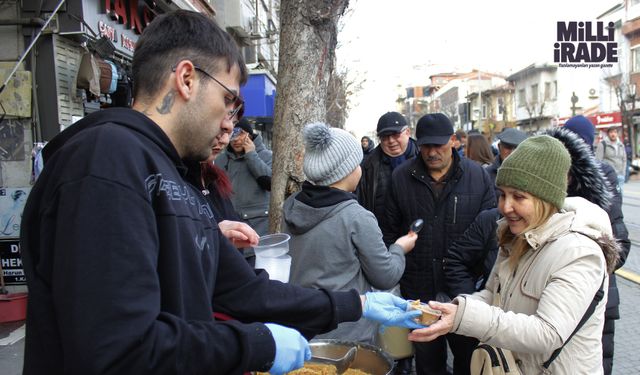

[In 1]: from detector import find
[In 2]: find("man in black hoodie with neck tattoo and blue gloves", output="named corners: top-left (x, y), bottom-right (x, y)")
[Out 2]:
top-left (21, 11), bottom-right (415, 375)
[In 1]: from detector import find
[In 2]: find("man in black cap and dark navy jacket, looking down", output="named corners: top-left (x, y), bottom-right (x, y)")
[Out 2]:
top-left (381, 113), bottom-right (496, 375)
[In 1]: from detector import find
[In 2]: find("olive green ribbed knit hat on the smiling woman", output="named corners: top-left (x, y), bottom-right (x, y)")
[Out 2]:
top-left (496, 135), bottom-right (571, 208)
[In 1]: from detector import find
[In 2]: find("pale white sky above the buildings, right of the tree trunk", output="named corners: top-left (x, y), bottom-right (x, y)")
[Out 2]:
top-left (336, 0), bottom-right (622, 137)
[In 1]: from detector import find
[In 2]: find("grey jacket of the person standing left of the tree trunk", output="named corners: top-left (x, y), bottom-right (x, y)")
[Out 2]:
top-left (216, 135), bottom-right (271, 236)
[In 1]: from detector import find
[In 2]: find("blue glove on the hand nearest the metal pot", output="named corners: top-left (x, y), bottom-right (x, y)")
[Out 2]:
top-left (265, 323), bottom-right (311, 375)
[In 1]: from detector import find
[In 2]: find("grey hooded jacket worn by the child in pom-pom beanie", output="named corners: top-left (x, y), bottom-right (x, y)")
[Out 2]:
top-left (283, 189), bottom-right (405, 343)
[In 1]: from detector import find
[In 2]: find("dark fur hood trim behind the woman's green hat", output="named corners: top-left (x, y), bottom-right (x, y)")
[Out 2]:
top-left (543, 127), bottom-right (612, 211)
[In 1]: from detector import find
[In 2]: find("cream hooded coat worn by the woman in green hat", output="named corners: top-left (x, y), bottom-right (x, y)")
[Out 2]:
top-left (453, 197), bottom-right (618, 375)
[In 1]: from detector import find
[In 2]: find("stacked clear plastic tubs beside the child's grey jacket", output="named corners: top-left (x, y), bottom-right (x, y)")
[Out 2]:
top-left (253, 233), bottom-right (291, 283)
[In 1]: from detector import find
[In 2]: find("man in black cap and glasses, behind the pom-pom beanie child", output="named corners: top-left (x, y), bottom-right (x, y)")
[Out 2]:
top-left (357, 112), bottom-right (418, 229)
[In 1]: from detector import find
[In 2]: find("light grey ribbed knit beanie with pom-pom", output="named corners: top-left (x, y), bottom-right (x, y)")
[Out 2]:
top-left (302, 123), bottom-right (362, 186)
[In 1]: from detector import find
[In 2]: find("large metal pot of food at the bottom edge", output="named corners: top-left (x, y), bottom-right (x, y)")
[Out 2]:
top-left (309, 339), bottom-right (393, 375)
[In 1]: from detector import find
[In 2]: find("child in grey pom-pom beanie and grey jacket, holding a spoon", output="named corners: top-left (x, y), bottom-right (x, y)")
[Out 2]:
top-left (283, 123), bottom-right (417, 343)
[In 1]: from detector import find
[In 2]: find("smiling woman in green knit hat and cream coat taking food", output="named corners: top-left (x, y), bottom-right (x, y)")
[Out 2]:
top-left (409, 135), bottom-right (618, 374)
